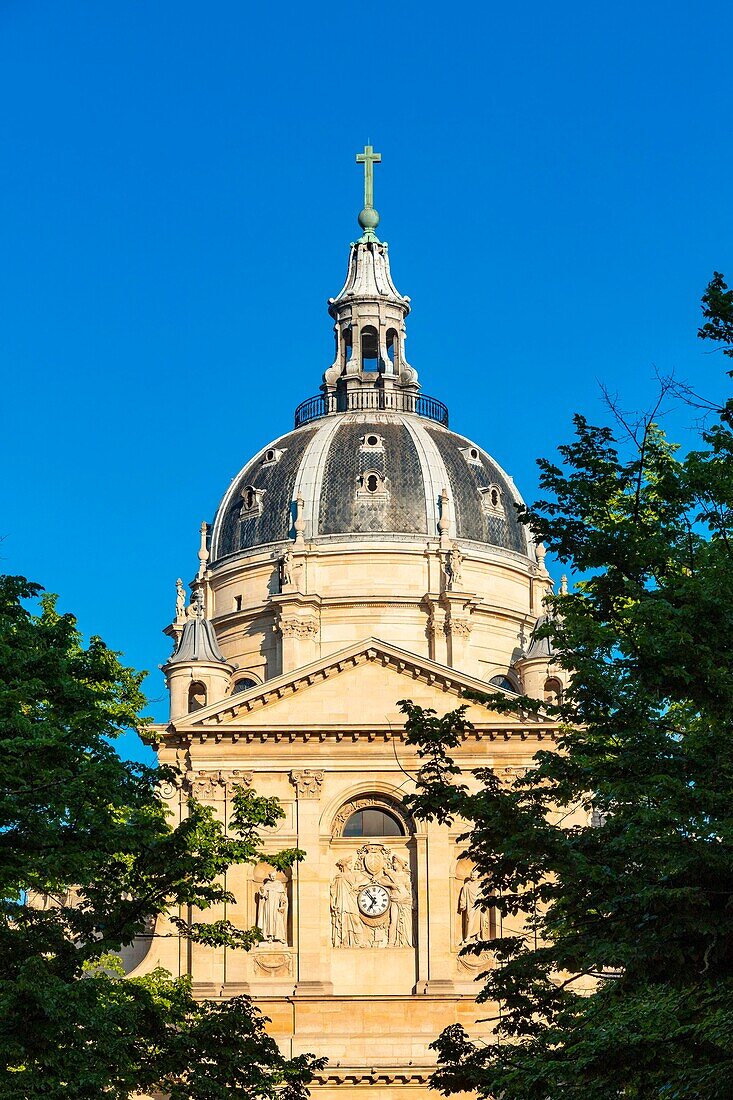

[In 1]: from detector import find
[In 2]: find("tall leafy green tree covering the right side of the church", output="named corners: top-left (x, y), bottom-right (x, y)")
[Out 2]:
top-left (403, 275), bottom-right (733, 1100)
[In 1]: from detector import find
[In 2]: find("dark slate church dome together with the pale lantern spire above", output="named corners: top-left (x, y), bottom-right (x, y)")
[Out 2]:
top-left (210, 167), bottom-right (528, 564)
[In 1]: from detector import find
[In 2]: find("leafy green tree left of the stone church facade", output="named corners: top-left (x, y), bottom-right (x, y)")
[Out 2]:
top-left (0, 576), bottom-right (319, 1100)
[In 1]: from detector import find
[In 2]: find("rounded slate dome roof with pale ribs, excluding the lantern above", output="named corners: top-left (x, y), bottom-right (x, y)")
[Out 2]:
top-left (210, 410), bottom-right (527, 564)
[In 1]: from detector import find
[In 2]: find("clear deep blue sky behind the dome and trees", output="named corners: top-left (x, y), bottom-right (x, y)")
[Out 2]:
top-left (0, 0), bottom-right (733, 761)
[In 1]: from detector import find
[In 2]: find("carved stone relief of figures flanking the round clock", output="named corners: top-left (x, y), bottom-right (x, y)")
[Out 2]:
top-left (330, 844), bottom-right (415, 947)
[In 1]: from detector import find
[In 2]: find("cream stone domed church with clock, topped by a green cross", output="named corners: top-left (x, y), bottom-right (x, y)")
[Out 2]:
top-left (138, 146), bottom-right (562, 1100)
